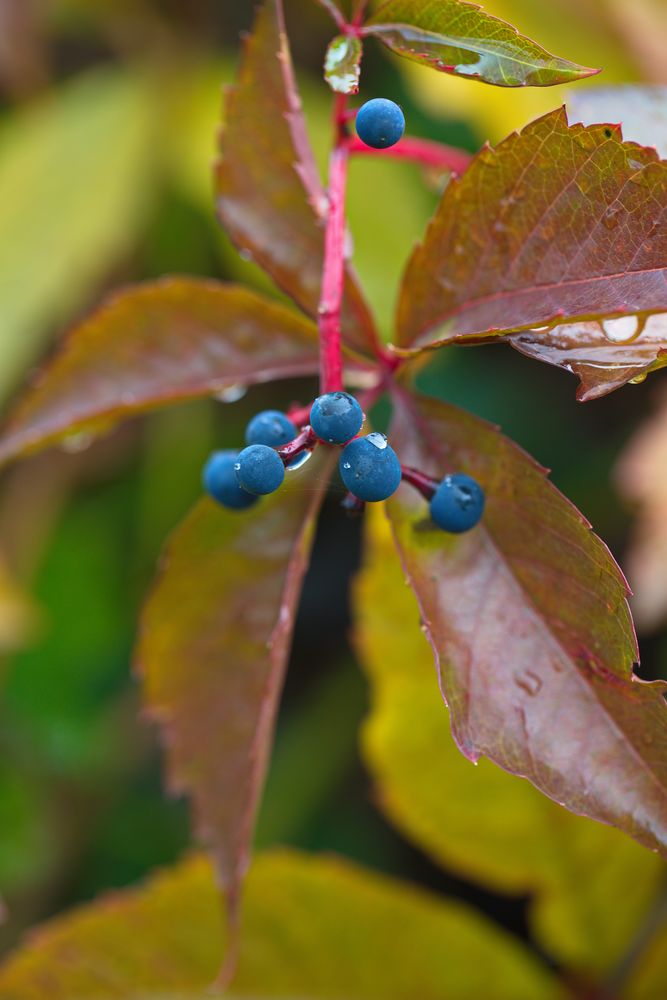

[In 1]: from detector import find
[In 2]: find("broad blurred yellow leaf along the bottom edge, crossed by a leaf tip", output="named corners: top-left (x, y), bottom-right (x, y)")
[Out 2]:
top-left (0, 851), bottom-right (566, 1000)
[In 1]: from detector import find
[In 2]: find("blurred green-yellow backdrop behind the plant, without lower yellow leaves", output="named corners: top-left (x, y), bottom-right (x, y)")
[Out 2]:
top-left (0, 0), bottom-right (667, 992)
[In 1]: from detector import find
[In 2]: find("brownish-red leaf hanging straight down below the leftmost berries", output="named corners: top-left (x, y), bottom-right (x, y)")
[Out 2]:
top-left (137, 453), bottom-right (333, 924)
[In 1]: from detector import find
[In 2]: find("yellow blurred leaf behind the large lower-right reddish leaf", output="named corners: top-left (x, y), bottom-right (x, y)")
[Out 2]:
top-left (354, 511), bottom-right (665, 976)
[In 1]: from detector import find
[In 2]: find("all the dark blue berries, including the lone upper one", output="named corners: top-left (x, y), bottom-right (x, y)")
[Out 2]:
top-left (203, 98), bottom-right (484, 534)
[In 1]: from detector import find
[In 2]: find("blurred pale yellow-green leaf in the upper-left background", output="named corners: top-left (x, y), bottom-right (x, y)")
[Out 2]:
top-left (0, 70), bottom-right (154, 400)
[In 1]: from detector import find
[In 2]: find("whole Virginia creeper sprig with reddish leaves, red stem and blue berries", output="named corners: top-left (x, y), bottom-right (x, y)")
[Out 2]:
top-left (0, 0), bottom-right (667, 988)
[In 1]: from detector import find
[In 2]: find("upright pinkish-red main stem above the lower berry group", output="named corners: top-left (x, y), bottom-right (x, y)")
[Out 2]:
top-left (318, 105), bottom-right (348, 393)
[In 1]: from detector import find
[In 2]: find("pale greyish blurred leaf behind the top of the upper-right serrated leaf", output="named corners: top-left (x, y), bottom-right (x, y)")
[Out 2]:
top-left (567, 84), bottom-right (667, 159)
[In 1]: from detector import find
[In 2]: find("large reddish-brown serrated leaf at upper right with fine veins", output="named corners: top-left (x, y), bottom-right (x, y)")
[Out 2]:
top-left (398, 109), bottom-right (667, 347)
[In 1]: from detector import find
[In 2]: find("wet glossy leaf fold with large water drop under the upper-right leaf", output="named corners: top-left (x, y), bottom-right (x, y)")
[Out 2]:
top-left (508, 313), bottom-right (667, 403)
